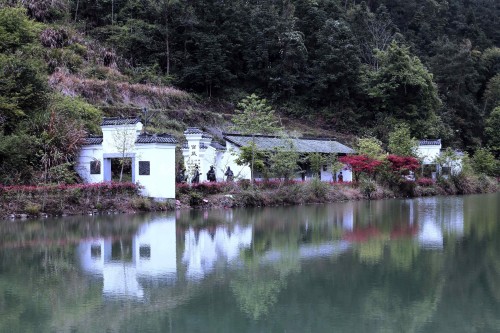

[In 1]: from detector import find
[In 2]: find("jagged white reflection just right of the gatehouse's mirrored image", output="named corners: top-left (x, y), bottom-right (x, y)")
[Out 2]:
top-left (182, 225), bottom-right (252, 278)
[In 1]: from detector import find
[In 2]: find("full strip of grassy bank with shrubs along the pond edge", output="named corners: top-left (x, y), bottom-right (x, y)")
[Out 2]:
top-left (0, 175), bottom-right (500, 219)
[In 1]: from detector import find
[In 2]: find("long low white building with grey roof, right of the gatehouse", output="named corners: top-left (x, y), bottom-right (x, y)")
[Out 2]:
top-left (182, 127), bottom-right (354, 181)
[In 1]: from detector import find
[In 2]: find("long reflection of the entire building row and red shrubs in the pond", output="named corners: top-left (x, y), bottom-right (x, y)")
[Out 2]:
top-left (77, 193), bottom-right (464, 299)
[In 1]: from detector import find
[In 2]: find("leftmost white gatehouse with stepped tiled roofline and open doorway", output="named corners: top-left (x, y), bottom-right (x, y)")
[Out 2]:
top-left (76, 118), bottom-right (177, 199)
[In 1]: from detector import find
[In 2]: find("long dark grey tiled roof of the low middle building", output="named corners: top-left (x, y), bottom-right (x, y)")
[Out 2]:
top-left (223, 133), bottom-right (355, 154)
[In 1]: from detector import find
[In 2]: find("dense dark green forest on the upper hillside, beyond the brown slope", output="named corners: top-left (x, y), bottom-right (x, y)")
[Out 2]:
top-left (42, 0), bottom-right (500, 149)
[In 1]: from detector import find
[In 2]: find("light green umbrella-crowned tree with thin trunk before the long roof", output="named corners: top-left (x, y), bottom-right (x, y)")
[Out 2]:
top-left (232, 94), bottom-right (280, 183)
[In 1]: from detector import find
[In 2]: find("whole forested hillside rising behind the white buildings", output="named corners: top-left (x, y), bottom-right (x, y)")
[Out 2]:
top-left (0, 0), bottom-right (500, 184)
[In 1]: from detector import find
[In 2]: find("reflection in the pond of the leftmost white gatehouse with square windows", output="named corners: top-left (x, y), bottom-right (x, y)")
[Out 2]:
top-left (78, 216), bottom-right (177, 298)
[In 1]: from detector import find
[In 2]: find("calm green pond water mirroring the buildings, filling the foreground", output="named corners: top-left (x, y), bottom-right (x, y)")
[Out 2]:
top-left (0, 193), bottom-right (500, 333)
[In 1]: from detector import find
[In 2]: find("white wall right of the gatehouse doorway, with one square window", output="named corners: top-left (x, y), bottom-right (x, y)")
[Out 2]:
top-left (135, 143), bottom-right (175, 199)
